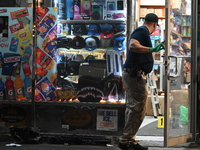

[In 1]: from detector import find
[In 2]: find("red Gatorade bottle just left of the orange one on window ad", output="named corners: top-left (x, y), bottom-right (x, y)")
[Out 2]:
top-left (5, 76), bottom-right (15, 100)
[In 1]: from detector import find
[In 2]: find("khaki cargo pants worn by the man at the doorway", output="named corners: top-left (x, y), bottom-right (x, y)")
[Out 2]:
top-left (120, 71), bottom-right (148, 144)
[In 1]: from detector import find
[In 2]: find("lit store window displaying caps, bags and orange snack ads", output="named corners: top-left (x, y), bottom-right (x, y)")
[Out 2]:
top-left (36, 0), bottom-right (126, 103)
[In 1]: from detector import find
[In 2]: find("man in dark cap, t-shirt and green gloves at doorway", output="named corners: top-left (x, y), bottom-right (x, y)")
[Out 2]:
top-left (118, 13), bottom-right (165, 150)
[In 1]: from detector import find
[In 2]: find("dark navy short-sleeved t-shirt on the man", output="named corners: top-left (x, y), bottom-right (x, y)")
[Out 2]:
top-left (124, 26), bottom-right (154, 73)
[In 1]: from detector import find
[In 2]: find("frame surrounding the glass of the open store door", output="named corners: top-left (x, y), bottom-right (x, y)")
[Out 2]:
top-left (164, 0), bottom-right (198, 147)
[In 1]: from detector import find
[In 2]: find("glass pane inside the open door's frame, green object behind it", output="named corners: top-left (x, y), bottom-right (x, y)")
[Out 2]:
top-left (169, 0), bottom-right (192, 137)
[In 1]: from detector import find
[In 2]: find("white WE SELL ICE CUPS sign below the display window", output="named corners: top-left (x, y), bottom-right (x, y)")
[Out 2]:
top-left (96, 109), bottom-right (118, 131)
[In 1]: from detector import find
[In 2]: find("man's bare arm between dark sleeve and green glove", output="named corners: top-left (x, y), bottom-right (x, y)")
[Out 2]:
top-left (129, 39), bottom-right (150, 53)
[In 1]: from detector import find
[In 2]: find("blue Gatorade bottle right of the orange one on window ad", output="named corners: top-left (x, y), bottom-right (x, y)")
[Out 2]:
top-left (24, 74), bottom-right (32, 100)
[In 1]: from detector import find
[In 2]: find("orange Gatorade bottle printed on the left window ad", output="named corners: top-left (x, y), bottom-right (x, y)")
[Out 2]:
top-left (14, 75), bottom-right (26, 101)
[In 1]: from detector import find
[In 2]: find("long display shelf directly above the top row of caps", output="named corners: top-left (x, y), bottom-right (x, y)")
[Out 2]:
top-left (60, 20), bottom-right (125, 24)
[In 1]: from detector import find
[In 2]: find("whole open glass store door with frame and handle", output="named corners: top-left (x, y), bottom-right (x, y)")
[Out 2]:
top-left (164, 0), bottom-right (196, 147)
